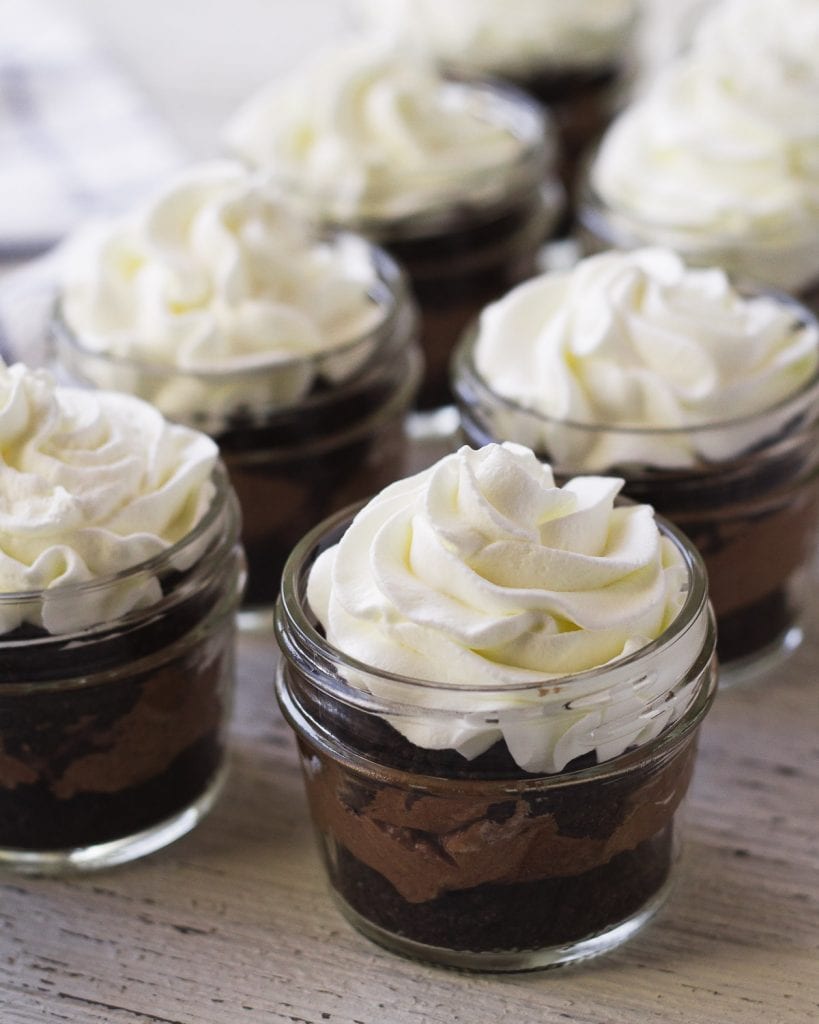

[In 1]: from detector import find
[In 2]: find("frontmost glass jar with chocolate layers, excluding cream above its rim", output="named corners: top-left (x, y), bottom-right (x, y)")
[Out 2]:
top-left (276, 501), bottom-right (716, 971)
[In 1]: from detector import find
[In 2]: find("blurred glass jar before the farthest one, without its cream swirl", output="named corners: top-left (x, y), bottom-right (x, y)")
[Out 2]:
top-left (266, 81), bottom-right (563, 409)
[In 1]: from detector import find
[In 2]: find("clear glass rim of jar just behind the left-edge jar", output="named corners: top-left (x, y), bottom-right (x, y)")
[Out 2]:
top-left (51, 234), bottom-right (413, 383)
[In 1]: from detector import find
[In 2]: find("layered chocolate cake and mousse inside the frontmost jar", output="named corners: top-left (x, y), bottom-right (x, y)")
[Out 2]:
top-left (285, 663), bottom-right (696, 952)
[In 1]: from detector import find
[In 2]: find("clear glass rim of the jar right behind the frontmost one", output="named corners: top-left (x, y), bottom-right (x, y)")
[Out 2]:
top-left (452, 288), bottom-right (819, 437)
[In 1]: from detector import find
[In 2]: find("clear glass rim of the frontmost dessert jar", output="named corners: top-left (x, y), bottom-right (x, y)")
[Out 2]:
top-left (275, 493), bottom-right (707, 696)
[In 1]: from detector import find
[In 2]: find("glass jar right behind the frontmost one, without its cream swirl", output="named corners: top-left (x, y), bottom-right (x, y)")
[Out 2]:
top-left (452, 323), bottom-right (819, 684)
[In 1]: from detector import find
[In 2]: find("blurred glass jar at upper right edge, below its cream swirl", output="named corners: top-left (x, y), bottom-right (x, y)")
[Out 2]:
top-left (577, 169), bottom-right (819, 313)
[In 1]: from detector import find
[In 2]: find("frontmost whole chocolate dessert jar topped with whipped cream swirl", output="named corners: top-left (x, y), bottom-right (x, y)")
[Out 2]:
top-left (276, 444), bottom-right (716, 971)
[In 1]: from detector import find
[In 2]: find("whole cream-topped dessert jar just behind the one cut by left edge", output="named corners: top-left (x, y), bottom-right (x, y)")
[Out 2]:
top-left (55, 162), bottom-right (421, 608)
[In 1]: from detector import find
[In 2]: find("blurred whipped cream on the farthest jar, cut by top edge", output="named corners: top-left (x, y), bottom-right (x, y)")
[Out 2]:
top-left (354, 0), bottom-right (637, 75)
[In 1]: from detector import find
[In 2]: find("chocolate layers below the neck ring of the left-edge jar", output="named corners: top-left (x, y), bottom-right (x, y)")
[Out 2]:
top-left (0, 624), bottom-right (232, 851)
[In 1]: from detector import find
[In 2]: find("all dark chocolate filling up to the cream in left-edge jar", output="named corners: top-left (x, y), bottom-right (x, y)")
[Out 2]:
top-left (0, 557), bottom-right (232, 852)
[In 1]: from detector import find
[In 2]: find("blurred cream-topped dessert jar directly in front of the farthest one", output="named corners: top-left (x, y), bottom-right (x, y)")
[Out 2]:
top-left (227, 39), bottom-right (562, 408)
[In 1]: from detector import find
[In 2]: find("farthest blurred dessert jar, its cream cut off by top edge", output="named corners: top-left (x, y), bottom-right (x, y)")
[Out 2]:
top-left (351, 0), bottom-right (638, 201)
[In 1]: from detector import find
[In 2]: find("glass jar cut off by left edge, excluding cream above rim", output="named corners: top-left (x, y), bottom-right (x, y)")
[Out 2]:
top-left (0, 464), bottom-right (244, 873)
